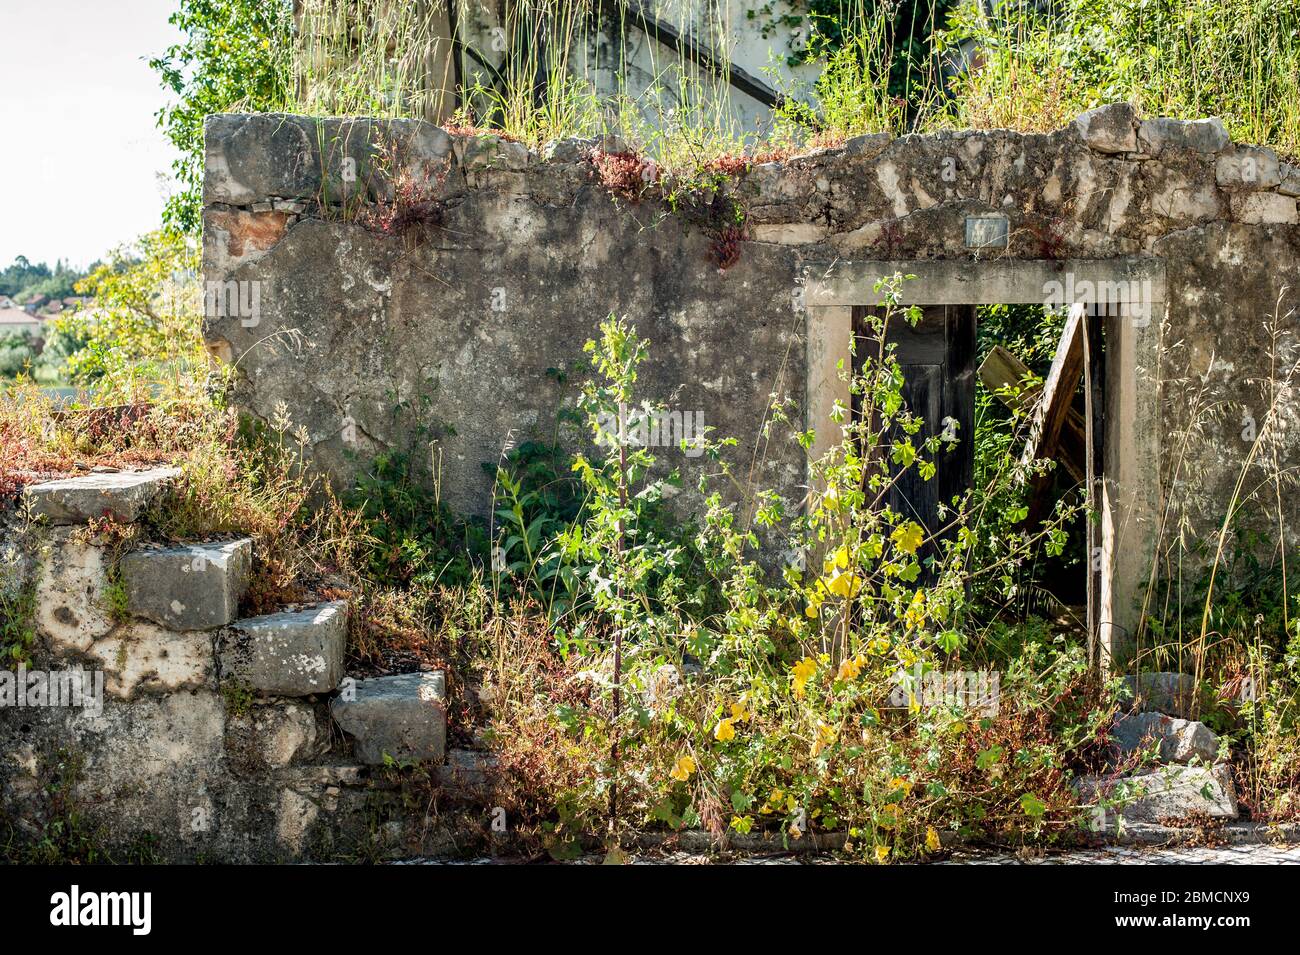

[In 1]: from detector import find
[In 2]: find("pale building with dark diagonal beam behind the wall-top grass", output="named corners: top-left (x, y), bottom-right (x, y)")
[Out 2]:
top-left (295, 0), bottom-right (818, 131)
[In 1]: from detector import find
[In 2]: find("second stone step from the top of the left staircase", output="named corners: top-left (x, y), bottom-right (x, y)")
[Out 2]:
top-left (118, 538), bottom-right (252, 630)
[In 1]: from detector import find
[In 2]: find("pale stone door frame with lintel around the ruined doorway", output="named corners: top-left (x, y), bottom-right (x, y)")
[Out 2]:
top-left (800, 257), bottom-right (1167, 669)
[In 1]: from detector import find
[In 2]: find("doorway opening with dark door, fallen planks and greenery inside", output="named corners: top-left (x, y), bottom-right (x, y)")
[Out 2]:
top-left (852, 303), bottom-right (1105, 621)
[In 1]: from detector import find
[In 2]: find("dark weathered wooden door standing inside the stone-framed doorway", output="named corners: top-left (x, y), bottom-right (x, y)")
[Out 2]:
top-left (853, 305), bottom-right (975, 556)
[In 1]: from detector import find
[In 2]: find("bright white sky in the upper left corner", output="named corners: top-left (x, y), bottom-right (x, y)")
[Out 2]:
top-left (0, 0), bottom-right (179, 268)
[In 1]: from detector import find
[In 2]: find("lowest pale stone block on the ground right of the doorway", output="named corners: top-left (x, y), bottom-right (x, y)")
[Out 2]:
top-left (1079, 763), bottom-right (1238, 828)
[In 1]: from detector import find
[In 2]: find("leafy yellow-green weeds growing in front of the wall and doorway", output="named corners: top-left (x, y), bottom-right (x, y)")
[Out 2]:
top-left (473, 279), bottom-right (1110, 860)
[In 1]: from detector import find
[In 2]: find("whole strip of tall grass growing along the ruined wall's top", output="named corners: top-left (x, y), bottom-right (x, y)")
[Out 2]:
top-left (283, 0), bottom-right (1300, 155)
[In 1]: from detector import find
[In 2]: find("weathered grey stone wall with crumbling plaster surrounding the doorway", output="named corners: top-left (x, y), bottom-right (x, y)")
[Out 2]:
top-left (204, 105), bottom-right (1300, 631)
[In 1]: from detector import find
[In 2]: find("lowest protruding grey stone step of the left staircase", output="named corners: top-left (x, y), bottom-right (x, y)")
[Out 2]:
top-left (330, 670), bottom-right (447, 765)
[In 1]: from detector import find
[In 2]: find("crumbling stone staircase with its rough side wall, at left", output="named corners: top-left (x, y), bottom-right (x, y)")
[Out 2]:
top-left (0, 468), bottom-right (457, 860)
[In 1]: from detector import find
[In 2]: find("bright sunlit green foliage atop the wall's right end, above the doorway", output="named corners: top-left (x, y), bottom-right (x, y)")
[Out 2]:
top-left (940, 0), bottom-right (1300, 153)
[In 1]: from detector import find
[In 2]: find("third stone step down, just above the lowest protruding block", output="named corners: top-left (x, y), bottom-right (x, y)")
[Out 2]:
top-left (217, 600), bottom-right (347, 696)
